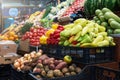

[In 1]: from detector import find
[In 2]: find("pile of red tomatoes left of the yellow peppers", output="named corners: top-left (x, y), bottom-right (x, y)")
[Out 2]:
top-left (22, 27), bottom-right (47, 46)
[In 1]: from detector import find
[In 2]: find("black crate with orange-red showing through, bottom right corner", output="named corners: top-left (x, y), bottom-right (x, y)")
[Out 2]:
top-left (91, 66), bottom-right (120, 80)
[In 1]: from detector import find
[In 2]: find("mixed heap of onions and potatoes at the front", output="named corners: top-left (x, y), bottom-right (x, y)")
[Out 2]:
top-left (14, 50), bottom-right (81, 78)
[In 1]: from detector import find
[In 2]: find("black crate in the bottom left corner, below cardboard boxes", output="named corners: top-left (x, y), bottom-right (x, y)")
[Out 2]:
top-left (0, 64), bottom-right (11, 80)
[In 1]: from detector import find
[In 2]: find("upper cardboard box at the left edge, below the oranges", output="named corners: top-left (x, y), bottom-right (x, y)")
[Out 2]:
top-left (0, 41), bottom-right (17, 56)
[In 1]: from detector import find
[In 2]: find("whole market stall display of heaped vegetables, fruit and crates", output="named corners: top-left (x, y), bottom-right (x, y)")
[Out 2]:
top-left (0, 0), bottom-right (120, 80)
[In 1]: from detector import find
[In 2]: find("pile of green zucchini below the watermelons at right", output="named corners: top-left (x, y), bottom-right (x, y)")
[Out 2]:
top-left (93, 8), bottom-right (120, 34)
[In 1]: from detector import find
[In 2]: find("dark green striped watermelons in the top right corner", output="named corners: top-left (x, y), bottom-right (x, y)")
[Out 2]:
top-left (84, 0), bottom-right (117, 17)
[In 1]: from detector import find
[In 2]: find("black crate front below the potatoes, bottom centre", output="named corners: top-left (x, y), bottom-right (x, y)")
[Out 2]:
top-left (29, 67), bottom-right (91, 80)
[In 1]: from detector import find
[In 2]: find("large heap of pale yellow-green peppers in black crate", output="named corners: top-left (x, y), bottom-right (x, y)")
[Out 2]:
top-left (59, 18), bottom-right (115, 47)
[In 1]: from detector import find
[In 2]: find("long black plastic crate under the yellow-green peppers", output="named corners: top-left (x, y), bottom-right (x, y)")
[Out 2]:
top-left (41, 45), bottom-right (115, 64)
